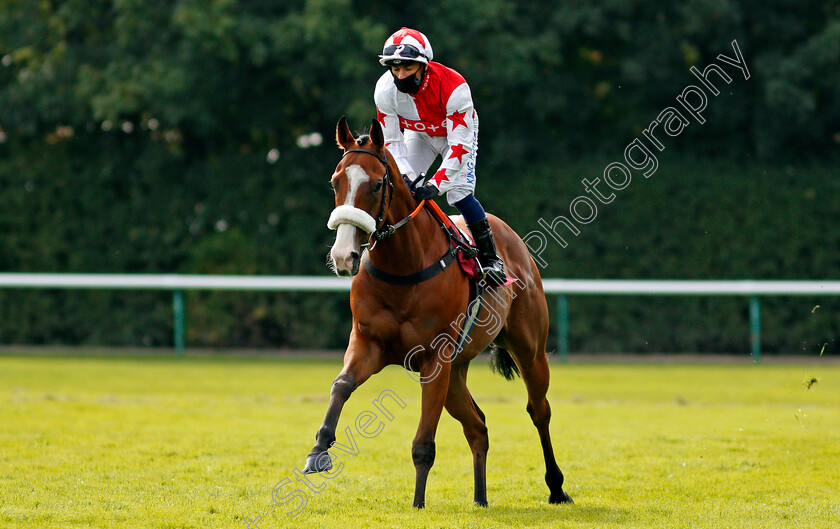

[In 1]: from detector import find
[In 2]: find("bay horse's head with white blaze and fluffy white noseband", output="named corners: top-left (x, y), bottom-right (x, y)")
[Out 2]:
top-left (327, 117), bottom-right (393, 276)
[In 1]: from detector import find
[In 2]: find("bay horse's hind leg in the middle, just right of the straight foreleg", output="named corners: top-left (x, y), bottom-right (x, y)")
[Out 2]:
top-left (445, 364), bottom-right (489, 507)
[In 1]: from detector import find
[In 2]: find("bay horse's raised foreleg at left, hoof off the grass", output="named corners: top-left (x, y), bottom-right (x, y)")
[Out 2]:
top-left (303, 332), bottom-right (384, 474)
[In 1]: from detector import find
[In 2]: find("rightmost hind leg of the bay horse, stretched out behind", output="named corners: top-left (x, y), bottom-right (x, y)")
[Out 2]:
top-left (501, 293), bottom-right (572, 503)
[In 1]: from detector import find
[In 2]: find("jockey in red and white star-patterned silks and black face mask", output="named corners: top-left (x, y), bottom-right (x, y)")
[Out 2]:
top-left (374, 28), bottom-right (506, 285)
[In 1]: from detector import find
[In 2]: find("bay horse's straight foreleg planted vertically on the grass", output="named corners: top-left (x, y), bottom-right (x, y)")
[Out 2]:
top-left (411, 357), bottom-right (451, 509)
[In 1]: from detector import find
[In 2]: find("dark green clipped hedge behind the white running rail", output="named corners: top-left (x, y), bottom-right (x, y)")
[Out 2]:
top-left (0, 142), bottom-right (840, 354)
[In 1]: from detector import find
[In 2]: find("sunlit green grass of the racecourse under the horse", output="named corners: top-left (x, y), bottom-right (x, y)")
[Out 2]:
top-left (0, 350), bottom-right (840, 529)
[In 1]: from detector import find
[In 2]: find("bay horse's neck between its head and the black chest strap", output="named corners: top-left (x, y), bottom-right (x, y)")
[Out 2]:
top-left (368, 190), bottom-right (448, 275)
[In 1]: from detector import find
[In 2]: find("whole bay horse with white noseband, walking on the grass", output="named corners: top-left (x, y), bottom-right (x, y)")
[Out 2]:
top-left (304, 117), bottom-right (572, 508)
